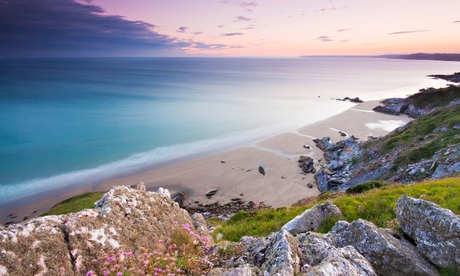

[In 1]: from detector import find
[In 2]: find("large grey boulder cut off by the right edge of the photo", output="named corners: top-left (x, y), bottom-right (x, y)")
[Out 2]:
top-left (395, 196), bottom-right (460, 270)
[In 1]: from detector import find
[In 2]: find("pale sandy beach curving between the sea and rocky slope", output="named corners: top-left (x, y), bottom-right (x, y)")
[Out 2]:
top-left (0, 101), bottom-right (411, 224)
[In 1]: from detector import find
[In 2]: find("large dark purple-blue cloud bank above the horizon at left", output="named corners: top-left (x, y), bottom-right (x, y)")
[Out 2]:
top-left (0, 0), bottom-right (184, 57)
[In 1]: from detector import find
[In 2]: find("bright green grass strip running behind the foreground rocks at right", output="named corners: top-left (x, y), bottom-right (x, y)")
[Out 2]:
top-left (217, 177), bottom-right (460, 241)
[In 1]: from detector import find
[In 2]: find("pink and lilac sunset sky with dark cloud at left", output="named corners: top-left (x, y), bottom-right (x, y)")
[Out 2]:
top-left (0, 0), bottom-right (460, 57)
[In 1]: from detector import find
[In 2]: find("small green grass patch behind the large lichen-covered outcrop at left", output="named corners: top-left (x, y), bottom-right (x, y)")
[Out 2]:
top-left (41, 192), bottom-right (106, 216)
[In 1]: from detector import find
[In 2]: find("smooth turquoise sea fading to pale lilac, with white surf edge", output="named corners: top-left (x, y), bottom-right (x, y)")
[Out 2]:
top-left (0, 57), bottom-right (460, 208)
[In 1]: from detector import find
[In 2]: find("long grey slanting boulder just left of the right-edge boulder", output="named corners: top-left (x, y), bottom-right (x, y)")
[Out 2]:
top-left (327, 219), bottom-right (439, 275)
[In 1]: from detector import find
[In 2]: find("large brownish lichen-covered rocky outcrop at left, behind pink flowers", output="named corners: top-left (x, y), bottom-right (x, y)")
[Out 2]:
top-left (0, 187), bottom-right (205, 275)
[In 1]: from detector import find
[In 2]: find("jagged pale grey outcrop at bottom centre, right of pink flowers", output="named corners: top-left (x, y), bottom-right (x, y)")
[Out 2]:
top-left (232, 230), bottom-right (377, 276)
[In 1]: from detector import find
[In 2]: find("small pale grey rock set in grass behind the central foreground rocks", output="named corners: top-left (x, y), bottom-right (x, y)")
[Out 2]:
top-left (281, 201), bottom-right (342, 235)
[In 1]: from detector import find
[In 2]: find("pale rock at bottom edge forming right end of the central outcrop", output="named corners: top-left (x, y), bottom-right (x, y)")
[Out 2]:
top-left (297, 232), bottom-right (377, 276)
